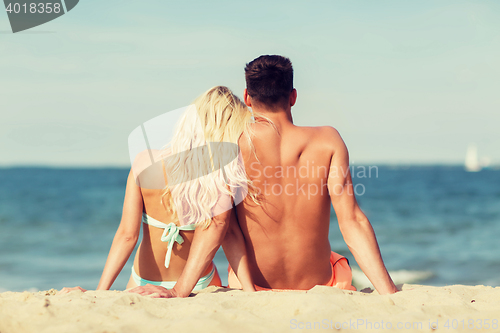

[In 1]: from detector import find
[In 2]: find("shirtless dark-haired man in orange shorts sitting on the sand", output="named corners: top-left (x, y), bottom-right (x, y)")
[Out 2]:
top-left (129, 55), bottom-right (397, 297)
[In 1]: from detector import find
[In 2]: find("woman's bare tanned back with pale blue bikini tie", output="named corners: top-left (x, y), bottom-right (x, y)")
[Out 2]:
top-left (127, 150), bottom-right (220, 288)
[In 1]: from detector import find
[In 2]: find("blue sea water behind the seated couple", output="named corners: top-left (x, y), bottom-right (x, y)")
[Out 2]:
top-left (0, 166), bottom-right (500, 291)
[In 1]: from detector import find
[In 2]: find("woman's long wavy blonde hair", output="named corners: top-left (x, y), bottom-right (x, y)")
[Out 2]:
top-left (162, 86), bottom-right (256, 226)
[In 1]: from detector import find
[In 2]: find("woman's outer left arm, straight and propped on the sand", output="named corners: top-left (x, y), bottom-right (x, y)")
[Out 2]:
top-left (97, 171), bottom-right (143, 290)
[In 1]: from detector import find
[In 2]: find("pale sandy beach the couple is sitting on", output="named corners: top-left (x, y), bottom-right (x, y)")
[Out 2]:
top-left (0, 284), bottom-right (500, 333)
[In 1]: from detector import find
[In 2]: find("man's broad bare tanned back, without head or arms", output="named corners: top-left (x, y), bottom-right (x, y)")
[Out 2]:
top-left (237, 120), bottom-right (338, 289)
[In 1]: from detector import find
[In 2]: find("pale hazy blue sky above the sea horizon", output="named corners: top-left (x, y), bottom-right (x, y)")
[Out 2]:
top-left (0, 0), bottom-right (500, 167)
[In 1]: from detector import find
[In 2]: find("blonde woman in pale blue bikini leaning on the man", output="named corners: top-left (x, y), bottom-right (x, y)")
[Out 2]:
top-left (61, 86), bottom-right (255, 296)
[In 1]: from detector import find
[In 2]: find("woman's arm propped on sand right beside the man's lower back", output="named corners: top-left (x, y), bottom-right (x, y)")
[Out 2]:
top-left (222, 209), bottom-right (255, 291)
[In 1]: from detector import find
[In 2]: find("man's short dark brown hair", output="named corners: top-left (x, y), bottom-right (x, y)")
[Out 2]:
top-left (245, 55), bottom-right (293, 104)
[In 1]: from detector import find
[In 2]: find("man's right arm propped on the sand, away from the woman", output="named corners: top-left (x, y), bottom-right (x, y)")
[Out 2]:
top-left (328, 129), bottom-right (398, 294)
